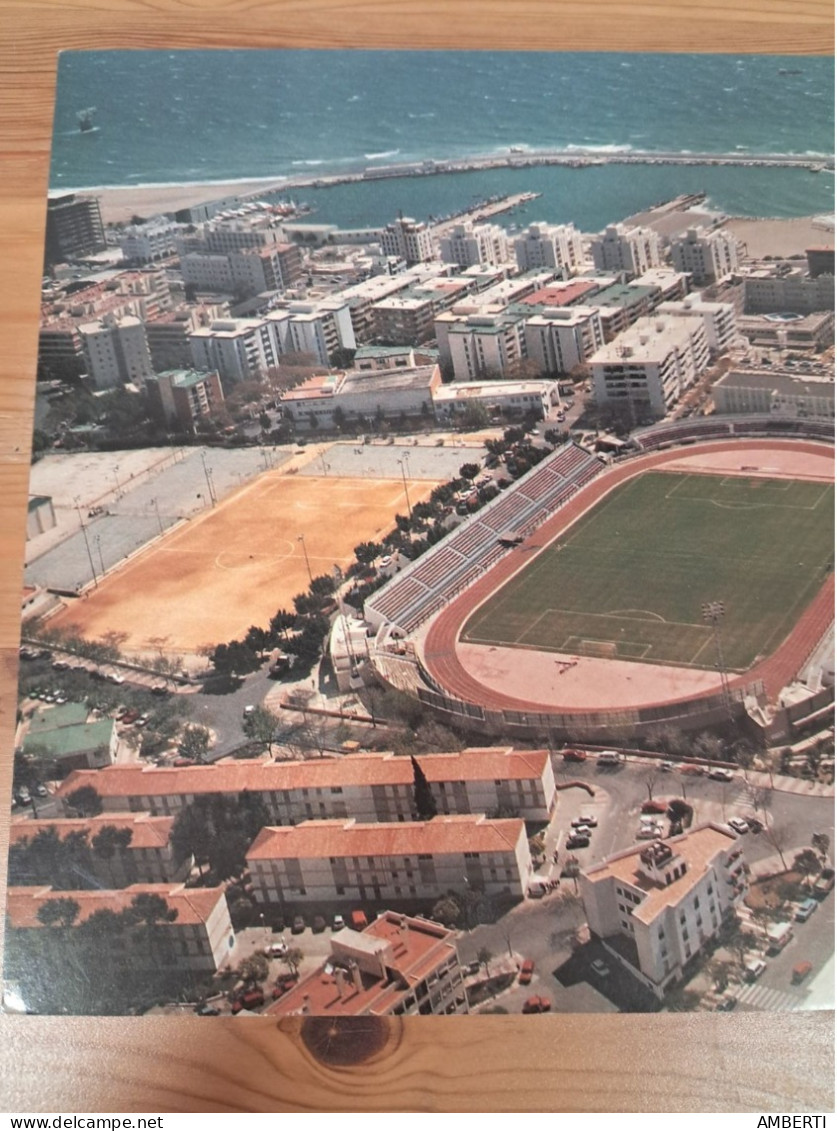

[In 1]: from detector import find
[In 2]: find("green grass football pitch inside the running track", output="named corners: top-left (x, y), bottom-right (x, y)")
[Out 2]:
top-left (463, 472), bottom-right (834, 671)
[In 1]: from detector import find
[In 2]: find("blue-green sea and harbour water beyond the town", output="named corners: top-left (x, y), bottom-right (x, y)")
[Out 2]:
top-left (50, 50), bottom-right (835, 231)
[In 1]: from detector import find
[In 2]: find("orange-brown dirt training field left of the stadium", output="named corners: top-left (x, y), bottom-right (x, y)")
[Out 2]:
top-left (51, 472), bottom-right (435, 654)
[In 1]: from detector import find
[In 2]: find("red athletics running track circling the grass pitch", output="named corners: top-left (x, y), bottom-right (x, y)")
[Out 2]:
top-left (419, 439), bottom-right (834, 715)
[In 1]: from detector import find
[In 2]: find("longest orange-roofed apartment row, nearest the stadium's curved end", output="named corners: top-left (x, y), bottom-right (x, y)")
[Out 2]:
top-left (57, 746), bottom-right (555, 824)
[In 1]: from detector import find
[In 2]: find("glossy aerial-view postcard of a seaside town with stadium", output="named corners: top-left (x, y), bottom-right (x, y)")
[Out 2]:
top-left (5, 50), bottom-right (835, 1017)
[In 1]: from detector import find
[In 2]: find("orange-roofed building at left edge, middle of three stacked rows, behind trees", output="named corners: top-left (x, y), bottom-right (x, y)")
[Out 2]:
top-left (9, 813), bottom-right (192, 888)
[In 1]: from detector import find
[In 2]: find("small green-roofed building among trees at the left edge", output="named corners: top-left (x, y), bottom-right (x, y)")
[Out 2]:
top-left (23, 702), bottom-right (119, 775)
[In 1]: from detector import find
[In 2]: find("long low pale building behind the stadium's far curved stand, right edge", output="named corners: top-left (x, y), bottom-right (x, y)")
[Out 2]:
top-left (713, 370), bottom-right (835, 421)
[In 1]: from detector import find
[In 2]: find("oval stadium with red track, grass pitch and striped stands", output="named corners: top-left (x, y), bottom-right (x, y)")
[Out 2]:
top-left (364, 416), bottom-right (834, 741)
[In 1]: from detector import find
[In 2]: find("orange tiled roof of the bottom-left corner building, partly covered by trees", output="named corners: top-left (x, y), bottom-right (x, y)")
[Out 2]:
top-left (7, 883), bottom-right (224, 927)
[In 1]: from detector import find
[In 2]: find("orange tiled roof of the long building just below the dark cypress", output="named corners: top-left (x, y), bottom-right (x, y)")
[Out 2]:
top-left (247, 814), bottom-right (524, 860)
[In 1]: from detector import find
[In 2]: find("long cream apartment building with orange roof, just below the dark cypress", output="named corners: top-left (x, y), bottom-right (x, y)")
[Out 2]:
top-left (247, 814), bottom-right (532, 906)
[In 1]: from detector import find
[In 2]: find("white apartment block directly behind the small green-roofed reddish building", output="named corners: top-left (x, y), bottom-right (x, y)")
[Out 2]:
top-left (189, 318), bottom-right (284, 388)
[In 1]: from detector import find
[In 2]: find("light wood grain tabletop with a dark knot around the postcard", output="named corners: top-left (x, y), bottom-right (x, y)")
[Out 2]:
top-left (0, 0), bottom-right (834, 1112)
